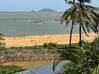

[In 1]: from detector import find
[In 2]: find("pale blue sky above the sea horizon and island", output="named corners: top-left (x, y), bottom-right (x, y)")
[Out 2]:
top-left (0, 0), bottom-right (99, 11)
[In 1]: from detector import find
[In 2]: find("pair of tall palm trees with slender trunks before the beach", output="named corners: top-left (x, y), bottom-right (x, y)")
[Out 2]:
top-left (61, 0), bottom-right (99, 47)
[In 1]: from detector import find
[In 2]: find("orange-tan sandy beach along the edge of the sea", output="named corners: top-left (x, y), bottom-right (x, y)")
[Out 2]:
top-left (4, 33), bottom-right (97, 47)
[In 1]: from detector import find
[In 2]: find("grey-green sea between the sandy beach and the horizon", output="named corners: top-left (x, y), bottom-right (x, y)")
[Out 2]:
top-left (0, 12), bottom-right (78, 37)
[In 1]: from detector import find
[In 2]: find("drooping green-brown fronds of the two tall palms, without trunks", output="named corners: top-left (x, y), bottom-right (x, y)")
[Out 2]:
top-left (61, 3), bottom-right (99, 44)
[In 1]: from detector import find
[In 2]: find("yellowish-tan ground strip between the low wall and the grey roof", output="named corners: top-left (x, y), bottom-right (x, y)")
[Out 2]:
top-left (2, 60), bottom-right (53, 69)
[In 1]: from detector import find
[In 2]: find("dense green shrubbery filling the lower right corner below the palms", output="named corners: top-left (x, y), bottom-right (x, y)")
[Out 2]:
top-left (53, 42), bottom-right (99, 74)
